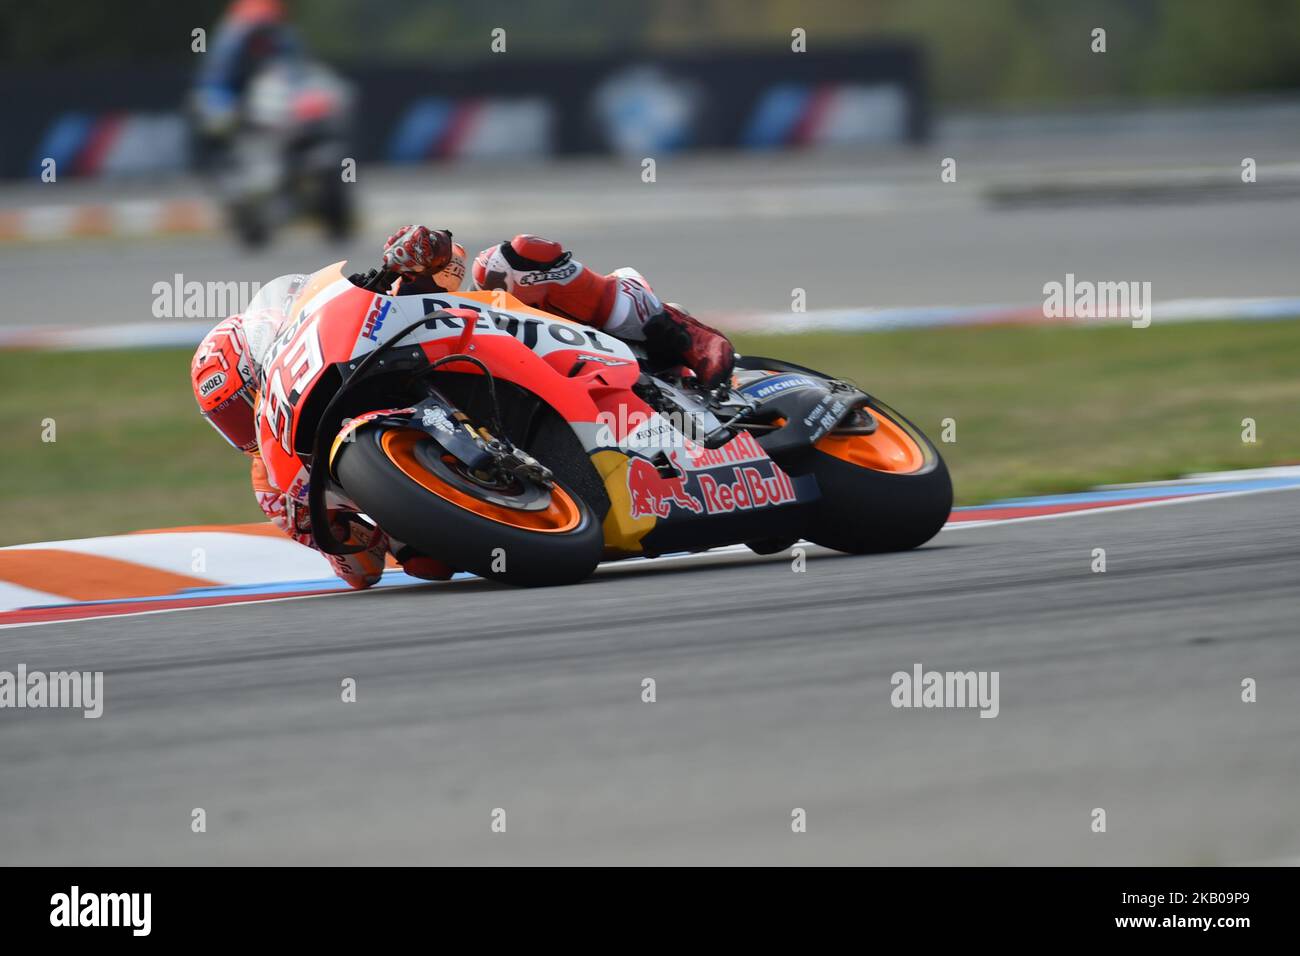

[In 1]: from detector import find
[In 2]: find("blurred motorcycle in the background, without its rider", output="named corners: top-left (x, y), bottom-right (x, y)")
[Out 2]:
top-left (220, 61), bottom-right (352, 248)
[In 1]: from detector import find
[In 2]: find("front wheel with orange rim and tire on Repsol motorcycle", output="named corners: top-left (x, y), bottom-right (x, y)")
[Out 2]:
top-left (335, 427), bottom-right (603, 587)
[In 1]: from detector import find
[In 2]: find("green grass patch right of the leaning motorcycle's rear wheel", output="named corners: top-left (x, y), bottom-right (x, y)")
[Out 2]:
top-left (737, 321), bottom-right (1300, 505)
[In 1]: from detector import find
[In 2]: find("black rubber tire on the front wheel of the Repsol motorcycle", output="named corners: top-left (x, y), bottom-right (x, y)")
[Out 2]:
top-left (335, 427), bottom-right (605, 587)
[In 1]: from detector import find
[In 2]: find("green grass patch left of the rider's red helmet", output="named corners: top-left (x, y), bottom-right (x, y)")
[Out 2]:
top-left (0, 349), bottom-right (261, 544)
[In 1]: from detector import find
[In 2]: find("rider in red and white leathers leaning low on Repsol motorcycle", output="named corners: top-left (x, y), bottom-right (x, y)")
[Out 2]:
top-left (190, 225), bottom-right (736, 588)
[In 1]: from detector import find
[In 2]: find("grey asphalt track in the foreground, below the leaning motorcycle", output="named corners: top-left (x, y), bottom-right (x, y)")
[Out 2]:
top-left (0, 490), bottom-right (1300, 864)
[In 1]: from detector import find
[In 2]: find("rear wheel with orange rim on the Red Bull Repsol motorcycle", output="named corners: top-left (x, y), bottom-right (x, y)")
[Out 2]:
top-left (781, 398), bottom-right (953, 554)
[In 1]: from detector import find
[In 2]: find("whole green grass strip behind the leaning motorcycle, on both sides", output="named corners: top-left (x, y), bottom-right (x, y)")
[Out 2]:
top-left (0, 323), bottom-right (1300, 544)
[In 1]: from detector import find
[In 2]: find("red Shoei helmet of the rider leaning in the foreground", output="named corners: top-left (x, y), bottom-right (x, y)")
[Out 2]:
top-left (190, 315), bottom-right (257, 453)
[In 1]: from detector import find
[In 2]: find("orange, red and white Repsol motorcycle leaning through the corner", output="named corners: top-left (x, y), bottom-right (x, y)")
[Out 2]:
top-left (250, 263), bottom-right (953, 585)
